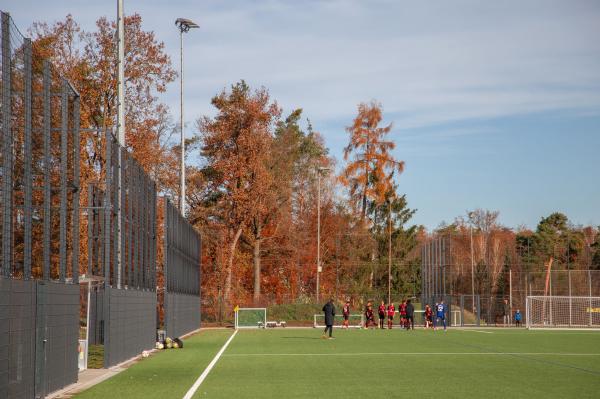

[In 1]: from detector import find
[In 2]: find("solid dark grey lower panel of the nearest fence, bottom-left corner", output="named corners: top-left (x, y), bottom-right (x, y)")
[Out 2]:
top-left (0, 278), bottom-right (79, 398)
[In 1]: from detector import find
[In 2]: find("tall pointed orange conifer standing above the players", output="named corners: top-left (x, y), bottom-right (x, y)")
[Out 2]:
top-left (341, 101), bottom-right (404, 220)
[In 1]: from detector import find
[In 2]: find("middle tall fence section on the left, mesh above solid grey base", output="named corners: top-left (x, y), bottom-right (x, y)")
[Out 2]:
top-left (87, 130), bottom-right (156, 367)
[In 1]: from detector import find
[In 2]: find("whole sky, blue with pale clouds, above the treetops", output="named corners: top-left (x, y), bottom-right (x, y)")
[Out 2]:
top-left (5, 0), bottom-right (600, 228)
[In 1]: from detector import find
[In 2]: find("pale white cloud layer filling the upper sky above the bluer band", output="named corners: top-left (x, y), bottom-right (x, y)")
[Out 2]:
top-left (7, 0), bottom-right (600, 131)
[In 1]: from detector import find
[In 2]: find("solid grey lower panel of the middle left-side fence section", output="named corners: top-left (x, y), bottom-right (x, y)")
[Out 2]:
top-left (104, 288), bottom-right (156, 367)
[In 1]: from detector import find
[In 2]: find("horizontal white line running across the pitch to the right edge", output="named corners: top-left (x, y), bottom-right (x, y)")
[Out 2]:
top-left (223, 352), bottom-right (600, 357)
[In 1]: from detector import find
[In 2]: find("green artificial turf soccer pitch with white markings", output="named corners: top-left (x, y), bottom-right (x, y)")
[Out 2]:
top-left (77, 328), bottom-right (600, 399)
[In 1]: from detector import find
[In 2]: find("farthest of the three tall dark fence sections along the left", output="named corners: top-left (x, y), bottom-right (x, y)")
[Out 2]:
top-left (164, 198), bottom-right (201, 337)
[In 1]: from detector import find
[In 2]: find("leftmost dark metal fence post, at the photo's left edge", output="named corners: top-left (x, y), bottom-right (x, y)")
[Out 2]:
top-left (2, 13), bottom-right (13, 276)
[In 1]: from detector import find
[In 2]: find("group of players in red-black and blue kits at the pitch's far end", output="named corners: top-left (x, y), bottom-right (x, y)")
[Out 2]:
top-left (342, 299), bottom-right (447, 331)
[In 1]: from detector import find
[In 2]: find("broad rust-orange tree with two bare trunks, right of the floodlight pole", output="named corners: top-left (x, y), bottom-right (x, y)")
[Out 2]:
top-left (198, 81), bottom-right (280, 299)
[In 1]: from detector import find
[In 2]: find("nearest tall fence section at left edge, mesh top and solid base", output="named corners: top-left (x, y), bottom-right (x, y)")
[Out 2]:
top-left (0, 12), bottom-right (80, 398)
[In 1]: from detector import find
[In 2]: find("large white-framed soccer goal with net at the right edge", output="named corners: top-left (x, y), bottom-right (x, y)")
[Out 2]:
top-left (525, 296), bottom-right (600, 328)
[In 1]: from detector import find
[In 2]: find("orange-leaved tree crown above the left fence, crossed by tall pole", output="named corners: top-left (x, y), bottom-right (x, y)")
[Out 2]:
top-left (30, 14), bottom-right (177, 190)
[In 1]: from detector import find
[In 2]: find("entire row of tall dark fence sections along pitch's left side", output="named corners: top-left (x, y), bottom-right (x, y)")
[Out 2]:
top-left (0, 12), bottom-right (200, 398)
